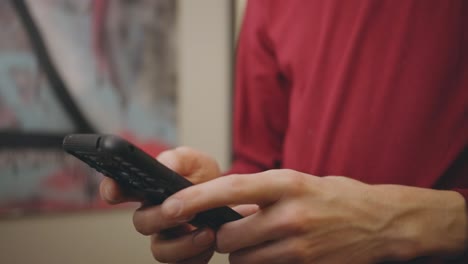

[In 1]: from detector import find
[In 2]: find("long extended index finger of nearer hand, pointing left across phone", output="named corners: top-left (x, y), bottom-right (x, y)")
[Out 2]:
top-left (162, 170), bottom-right (302, 219)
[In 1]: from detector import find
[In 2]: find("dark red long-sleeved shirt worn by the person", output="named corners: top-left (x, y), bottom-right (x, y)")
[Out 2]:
top-left (232, 0), bottom-right (468, 263)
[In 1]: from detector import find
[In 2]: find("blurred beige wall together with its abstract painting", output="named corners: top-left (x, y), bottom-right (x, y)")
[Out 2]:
top-left (0, 0), bottom-right (245, 264)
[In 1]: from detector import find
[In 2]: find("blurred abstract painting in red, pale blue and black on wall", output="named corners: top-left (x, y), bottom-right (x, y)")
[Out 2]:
top-left (0, 0), bottom-right (177, 216)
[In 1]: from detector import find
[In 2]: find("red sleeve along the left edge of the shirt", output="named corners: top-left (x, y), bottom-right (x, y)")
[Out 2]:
top-left (229, 0), bottom-right (289, 173)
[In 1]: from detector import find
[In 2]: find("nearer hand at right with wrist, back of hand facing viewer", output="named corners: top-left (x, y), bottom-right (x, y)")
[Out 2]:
top-left (158, 170), bottom-right (467, 264)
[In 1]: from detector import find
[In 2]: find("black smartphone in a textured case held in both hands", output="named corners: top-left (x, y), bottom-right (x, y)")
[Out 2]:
top-left (63, 134), bottom-right (242, 229)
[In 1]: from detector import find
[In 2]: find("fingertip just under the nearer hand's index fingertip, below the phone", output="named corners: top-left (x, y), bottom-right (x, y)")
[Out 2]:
top-left (133, 206), bottom-right (192, 236)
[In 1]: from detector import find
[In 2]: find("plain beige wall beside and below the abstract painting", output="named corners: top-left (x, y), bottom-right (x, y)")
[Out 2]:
top-left (0, 0), bottom-right (231, 264)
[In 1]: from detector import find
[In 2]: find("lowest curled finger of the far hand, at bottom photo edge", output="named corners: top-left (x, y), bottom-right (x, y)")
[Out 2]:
top-left (151, 228), bottom-right (215, 263)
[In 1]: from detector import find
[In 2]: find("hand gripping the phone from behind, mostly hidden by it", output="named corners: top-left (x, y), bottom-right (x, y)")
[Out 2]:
top-left (100, 147), bottom-right (221, 263)
